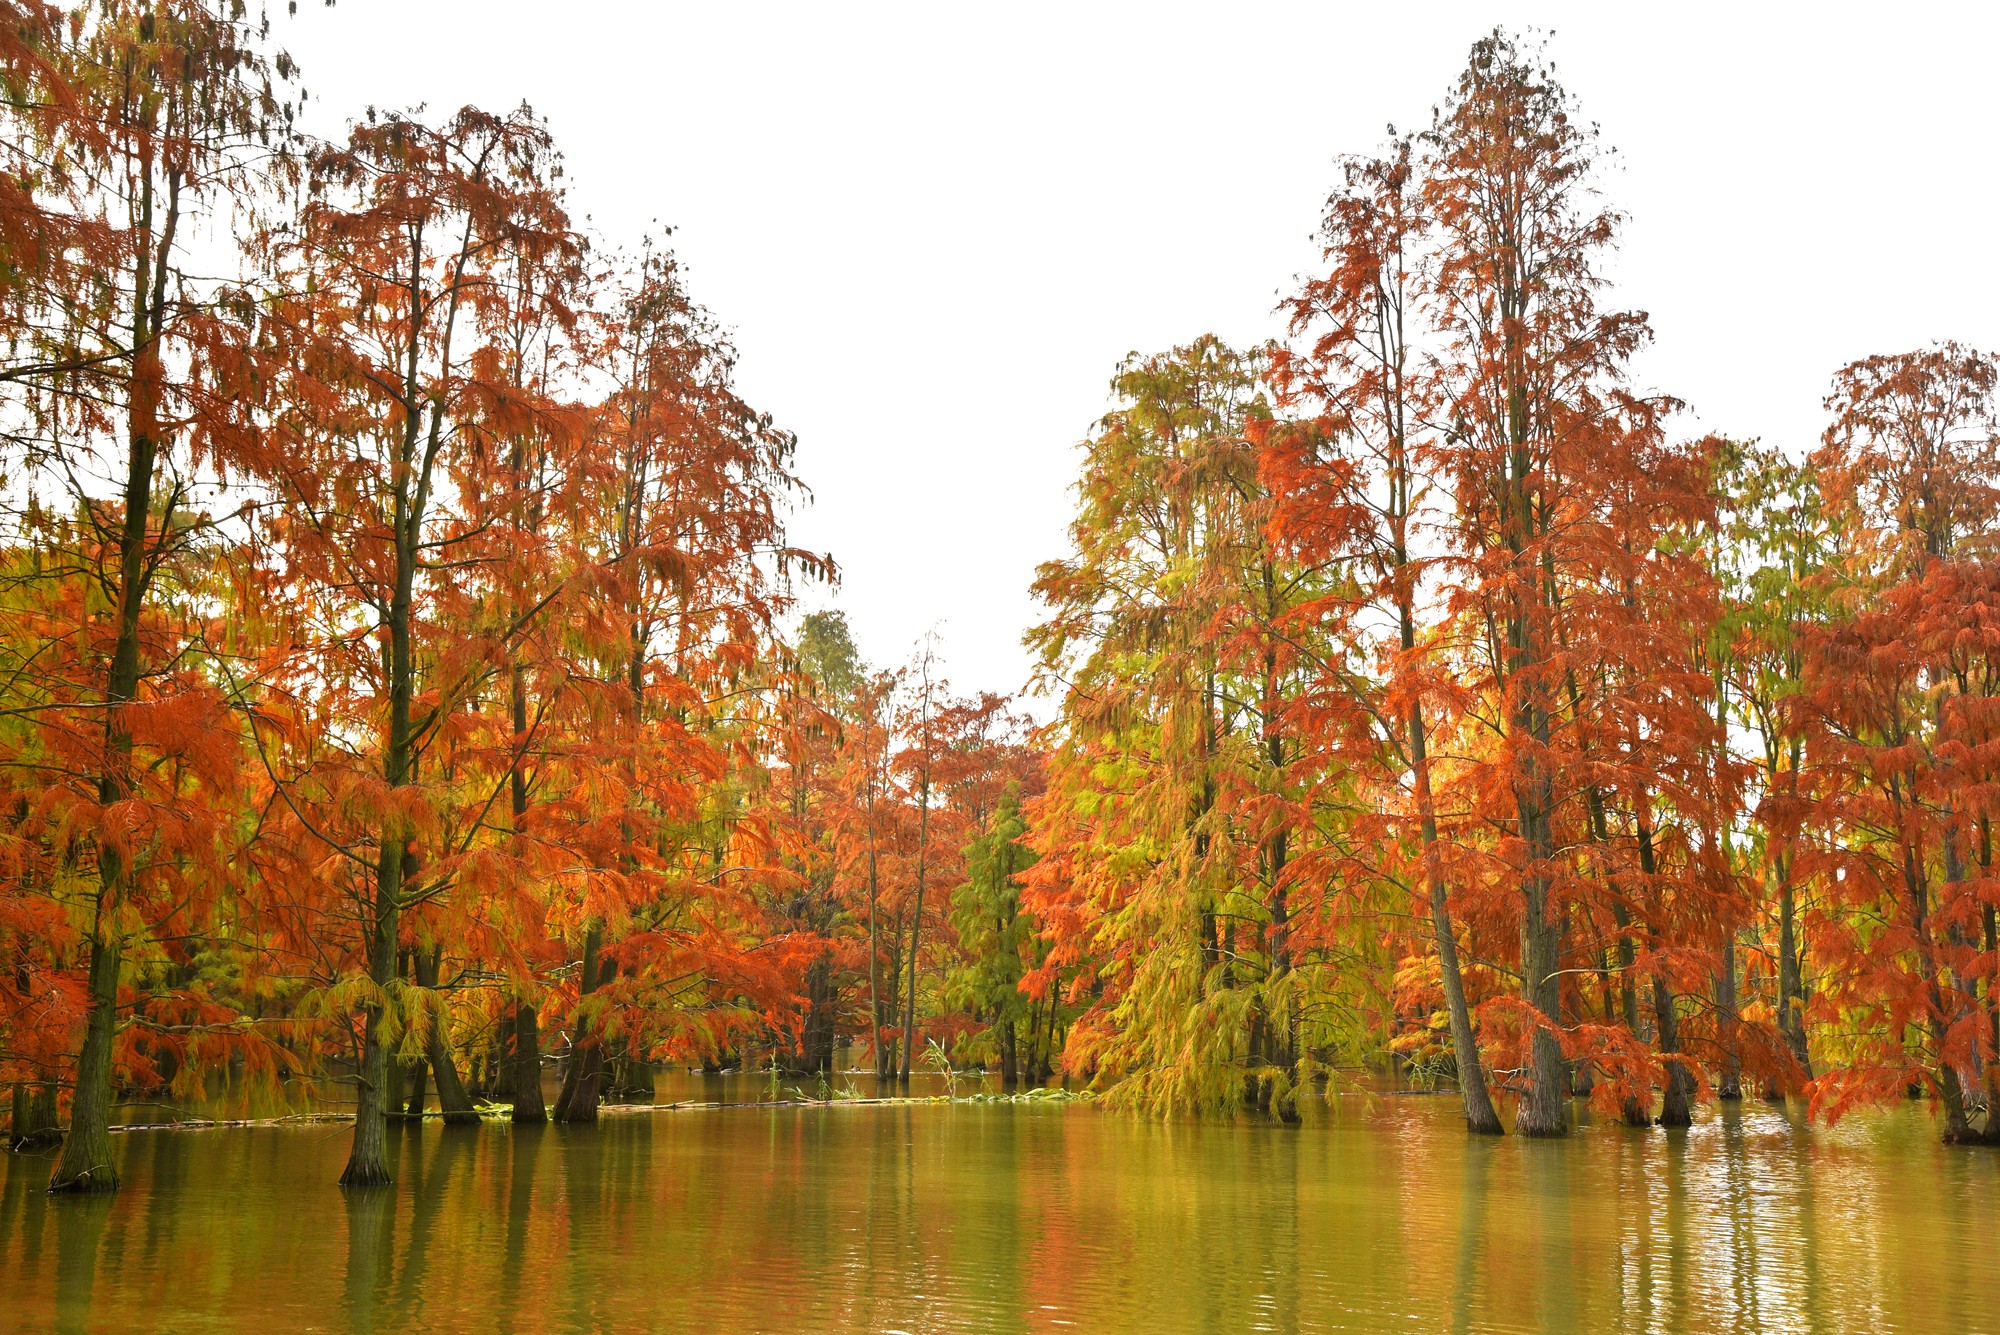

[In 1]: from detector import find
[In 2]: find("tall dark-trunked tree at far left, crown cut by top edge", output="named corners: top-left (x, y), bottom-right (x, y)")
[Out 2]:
top-left (0, 0), bottom-right (292, 1191)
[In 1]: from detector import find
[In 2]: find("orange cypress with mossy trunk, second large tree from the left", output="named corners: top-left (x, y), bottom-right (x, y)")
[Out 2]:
top-left (254, 108), bottom-right (582, 1187)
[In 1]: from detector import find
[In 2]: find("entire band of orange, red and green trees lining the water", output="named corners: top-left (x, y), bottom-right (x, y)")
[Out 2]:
top-left (0, 0), bottom-right (2000, 1191)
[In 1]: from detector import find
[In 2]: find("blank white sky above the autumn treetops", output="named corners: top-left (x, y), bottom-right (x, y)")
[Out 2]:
top-left (276, 0), bottom-right (2000, 691)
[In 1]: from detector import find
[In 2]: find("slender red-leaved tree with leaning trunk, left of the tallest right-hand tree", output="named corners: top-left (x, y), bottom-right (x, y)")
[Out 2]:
top-left (1264, 138), bottom-right (1502, 1135)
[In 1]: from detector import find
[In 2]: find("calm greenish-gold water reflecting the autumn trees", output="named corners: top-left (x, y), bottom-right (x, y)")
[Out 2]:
top-left (0, 1097), bottom-right (2000, 1335)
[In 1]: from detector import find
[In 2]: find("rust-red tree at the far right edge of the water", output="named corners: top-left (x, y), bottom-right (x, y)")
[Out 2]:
top-left (1796, 344), bottom-right (2000, 1141)
